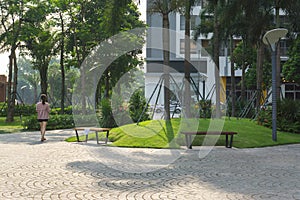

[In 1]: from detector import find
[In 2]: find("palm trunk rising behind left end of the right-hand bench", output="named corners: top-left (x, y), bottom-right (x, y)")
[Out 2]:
top-left (183, 1), bottom-right (191, 118)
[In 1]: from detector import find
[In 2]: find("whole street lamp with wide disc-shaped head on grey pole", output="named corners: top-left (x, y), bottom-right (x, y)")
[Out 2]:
top-left (263, 28), bottom-right (288, 141)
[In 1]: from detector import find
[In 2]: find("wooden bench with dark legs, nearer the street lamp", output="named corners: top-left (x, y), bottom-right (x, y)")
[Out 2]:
top-left (181, 131), bottom-right (237, 149)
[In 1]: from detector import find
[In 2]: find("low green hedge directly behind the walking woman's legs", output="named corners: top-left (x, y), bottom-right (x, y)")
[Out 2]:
top-left (22, 115), bottom-right (74, 130)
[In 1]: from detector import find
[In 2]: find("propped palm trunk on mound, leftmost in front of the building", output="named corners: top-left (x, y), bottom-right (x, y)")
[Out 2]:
top-left (163, 13), bottom-right (171, 121)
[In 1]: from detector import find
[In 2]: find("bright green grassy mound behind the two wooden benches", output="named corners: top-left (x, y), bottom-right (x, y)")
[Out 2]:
top-left (67, 119), bottom-right (300, 148)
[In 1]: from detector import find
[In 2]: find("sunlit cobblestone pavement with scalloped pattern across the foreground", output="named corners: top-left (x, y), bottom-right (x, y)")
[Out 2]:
top-left (0, 130), bottom-right (300, 200)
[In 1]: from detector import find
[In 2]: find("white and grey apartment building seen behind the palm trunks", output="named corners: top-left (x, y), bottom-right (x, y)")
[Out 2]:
top-left (145, 1), bottom-right (300, 109)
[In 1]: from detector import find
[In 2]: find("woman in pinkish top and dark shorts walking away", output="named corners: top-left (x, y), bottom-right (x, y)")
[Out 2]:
top-left (36, 94), bottom-right (50, 142)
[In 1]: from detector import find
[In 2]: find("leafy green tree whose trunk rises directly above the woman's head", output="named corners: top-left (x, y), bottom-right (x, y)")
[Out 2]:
top-left (22, 1), bottom-right (56, 94)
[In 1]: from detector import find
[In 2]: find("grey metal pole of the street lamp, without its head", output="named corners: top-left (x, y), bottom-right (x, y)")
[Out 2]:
top-left (272, 45), bottom-right (277, 141)
